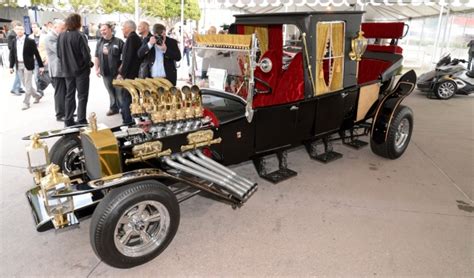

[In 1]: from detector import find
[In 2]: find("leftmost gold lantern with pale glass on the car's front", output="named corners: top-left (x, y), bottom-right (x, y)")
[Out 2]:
top-left (26, 134), bottom-right (49, 184)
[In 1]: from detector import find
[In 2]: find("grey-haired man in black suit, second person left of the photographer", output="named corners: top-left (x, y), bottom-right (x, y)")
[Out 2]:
top-left (117, 20), bottom-right (142, 124)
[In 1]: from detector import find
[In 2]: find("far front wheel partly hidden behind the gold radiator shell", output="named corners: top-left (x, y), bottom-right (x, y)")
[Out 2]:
top-left (50, 135), bottom-right (84, 174)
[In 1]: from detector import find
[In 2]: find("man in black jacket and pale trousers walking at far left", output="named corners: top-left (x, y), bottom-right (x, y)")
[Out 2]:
top-left (10, 25), bottom-right (44, 110)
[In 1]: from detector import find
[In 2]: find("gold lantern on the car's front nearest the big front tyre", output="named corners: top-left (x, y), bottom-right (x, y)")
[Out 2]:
top-left (41, 164), bottom-right (77, 229)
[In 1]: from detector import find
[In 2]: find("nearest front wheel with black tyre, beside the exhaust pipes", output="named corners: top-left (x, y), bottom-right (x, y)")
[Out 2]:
top-left (90, 180), bottom-right (179, 268)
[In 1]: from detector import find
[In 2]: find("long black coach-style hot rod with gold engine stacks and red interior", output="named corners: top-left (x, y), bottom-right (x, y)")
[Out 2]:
top-left (25, 12), bottom-right (416, 268)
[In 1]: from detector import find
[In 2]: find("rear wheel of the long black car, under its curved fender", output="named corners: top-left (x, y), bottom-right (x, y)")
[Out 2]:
top-left (370, 105), bottom-right (413, 159)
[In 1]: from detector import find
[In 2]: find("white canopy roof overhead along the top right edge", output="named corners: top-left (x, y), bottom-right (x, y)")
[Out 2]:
top-left (216, 0), bottom-right (474, 21)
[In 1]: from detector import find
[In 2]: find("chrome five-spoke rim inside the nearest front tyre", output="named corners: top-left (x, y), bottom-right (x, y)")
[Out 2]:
top-left (114, 201), bottom-right (170, 257)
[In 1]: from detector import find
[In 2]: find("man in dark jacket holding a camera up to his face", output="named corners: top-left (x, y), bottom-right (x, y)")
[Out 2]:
top-left (138, 24), bottom-right (181, 85)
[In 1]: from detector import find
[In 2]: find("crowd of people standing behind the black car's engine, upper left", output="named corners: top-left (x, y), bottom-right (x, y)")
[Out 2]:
top-left (7, 14), bottom-right (184, 127)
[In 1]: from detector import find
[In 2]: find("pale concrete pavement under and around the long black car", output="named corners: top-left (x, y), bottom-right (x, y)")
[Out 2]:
top-left (0, 68), bottom-right (474, 277)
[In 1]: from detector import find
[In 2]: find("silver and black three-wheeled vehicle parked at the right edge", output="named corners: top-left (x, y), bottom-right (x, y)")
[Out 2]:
top-left (416, 53), bottom-right (474, 99)
